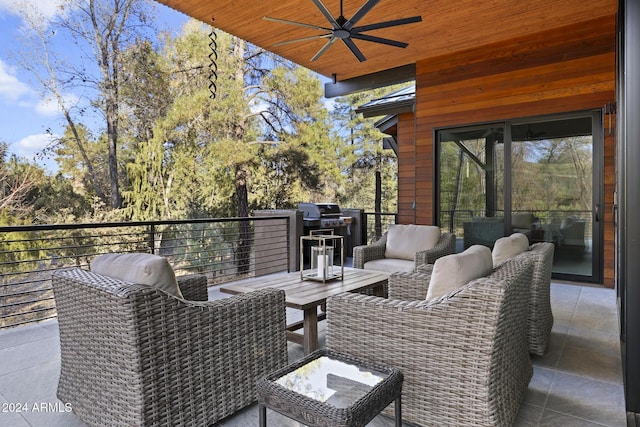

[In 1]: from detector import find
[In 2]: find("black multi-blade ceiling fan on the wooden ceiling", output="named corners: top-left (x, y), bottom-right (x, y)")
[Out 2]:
top-left (264, 0), bottom-right (422, 62)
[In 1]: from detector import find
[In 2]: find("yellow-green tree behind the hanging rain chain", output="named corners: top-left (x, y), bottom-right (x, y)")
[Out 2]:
top-left (125, 21), bottom-right (258, 219)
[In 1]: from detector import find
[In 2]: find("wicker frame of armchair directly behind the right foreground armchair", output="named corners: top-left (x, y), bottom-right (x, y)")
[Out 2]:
top-left (387, 242), bottom-right (554, 356)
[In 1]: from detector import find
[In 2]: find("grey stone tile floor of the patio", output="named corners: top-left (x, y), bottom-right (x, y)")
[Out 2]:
top-left (0, 283), bottom-right (627, 427)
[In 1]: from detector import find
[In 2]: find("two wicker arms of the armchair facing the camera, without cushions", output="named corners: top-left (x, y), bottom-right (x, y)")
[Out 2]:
top-left (353, 229), bottom-right (456, 270)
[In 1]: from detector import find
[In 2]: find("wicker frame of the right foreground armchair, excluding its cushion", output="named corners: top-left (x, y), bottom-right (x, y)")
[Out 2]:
top-left (327, 257), bottom-right (533, 426)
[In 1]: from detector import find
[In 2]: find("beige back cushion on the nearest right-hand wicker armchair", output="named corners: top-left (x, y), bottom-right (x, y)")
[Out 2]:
top-left (426, 245), bottom-right (493, 301)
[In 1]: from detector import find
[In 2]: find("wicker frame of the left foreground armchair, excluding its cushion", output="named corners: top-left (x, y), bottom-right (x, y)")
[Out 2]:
top-left (52, 269), bottom-right (287, 426)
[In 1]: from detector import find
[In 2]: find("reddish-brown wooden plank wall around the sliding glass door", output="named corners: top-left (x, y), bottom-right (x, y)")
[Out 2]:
top-left (398, 15), bottom-right (615, 286)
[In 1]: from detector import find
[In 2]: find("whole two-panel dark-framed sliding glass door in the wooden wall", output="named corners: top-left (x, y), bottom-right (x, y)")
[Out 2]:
top-left (436, 112), bottom-right (602, 281)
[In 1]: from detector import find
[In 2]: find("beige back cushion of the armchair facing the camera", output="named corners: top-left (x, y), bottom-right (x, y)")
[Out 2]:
top-left (384, 224), bottom-right (440, 261)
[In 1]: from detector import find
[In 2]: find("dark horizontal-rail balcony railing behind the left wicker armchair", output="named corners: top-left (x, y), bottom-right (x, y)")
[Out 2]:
top-left (0, 216), bottom-right (290, 329)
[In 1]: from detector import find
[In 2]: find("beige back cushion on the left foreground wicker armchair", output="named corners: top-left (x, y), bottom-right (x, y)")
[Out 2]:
top-left (91, 253), bottom-right (182, 298)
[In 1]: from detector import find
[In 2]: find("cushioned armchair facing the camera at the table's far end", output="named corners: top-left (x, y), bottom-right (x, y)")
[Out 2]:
top-left (353, 224), bottom-right (456, 273)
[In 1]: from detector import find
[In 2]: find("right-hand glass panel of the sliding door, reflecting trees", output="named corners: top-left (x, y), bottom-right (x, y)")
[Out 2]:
top-left (511, 115), bottom-right (597, 277)
